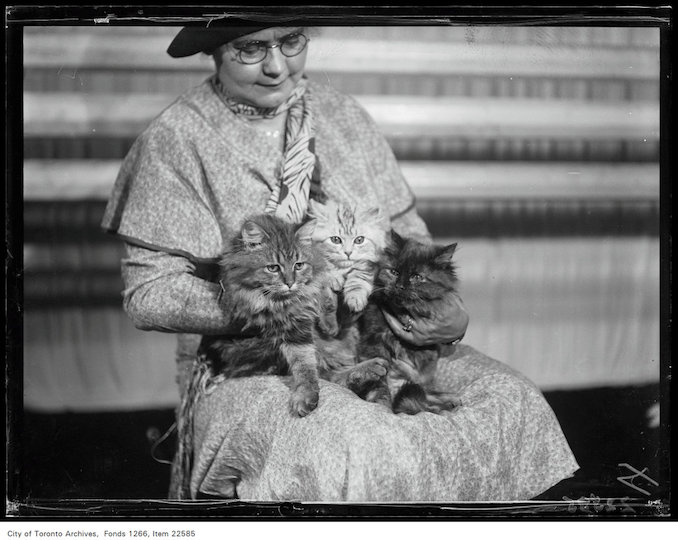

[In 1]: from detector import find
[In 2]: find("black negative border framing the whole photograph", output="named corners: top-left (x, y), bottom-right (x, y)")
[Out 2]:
top-left (5, 5), bottom-right (675, 521)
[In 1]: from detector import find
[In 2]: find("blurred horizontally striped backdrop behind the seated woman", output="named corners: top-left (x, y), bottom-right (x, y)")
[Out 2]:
top-left (18, 26), bottom-right (660, 498)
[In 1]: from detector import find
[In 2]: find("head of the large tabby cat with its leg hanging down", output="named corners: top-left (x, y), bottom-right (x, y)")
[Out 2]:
top-left (222, 215), bottom-right (321, 302)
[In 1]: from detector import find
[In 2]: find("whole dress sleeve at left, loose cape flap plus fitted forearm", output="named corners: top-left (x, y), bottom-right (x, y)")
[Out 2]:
top-left (102, 110), bottom-right (238, 334)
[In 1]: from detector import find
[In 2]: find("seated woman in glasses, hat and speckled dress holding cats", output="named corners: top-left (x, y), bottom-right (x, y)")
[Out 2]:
top-left (103, 23), bottom-right (577, 501)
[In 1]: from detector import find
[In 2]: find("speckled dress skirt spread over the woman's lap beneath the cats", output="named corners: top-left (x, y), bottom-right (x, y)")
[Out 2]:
top-left (191, 345), bottom-right (577, 501)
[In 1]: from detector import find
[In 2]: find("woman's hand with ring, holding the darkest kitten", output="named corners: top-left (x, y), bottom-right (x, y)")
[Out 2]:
top-left (382, 294), bottom-right (469, 347)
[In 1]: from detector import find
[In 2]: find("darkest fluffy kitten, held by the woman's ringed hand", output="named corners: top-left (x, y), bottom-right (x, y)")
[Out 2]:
top-left (352, 231), bottom-right (460, 414)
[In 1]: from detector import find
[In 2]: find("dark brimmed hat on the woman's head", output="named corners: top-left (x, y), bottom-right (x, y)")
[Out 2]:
top-left (167, 24), bottom-right (275, 58)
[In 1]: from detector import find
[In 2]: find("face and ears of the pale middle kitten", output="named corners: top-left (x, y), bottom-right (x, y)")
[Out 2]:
top-left (304, 201), bottom-right (387, 266)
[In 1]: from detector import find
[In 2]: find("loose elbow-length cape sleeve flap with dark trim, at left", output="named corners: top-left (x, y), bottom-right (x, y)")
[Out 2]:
top-left (102, 118), bottom-right (222, 263)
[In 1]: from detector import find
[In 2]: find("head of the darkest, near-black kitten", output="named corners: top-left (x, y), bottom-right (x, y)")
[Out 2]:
top-left (375, 232), bottom-right (458, 312)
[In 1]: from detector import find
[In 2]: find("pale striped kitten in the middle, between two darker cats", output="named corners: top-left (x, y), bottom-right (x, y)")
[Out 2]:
top-left (302, 200), bottom-right (390, 313)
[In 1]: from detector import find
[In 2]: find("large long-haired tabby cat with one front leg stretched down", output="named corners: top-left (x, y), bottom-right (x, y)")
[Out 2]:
top-left (198, 214), bottom-right (326, 416)
